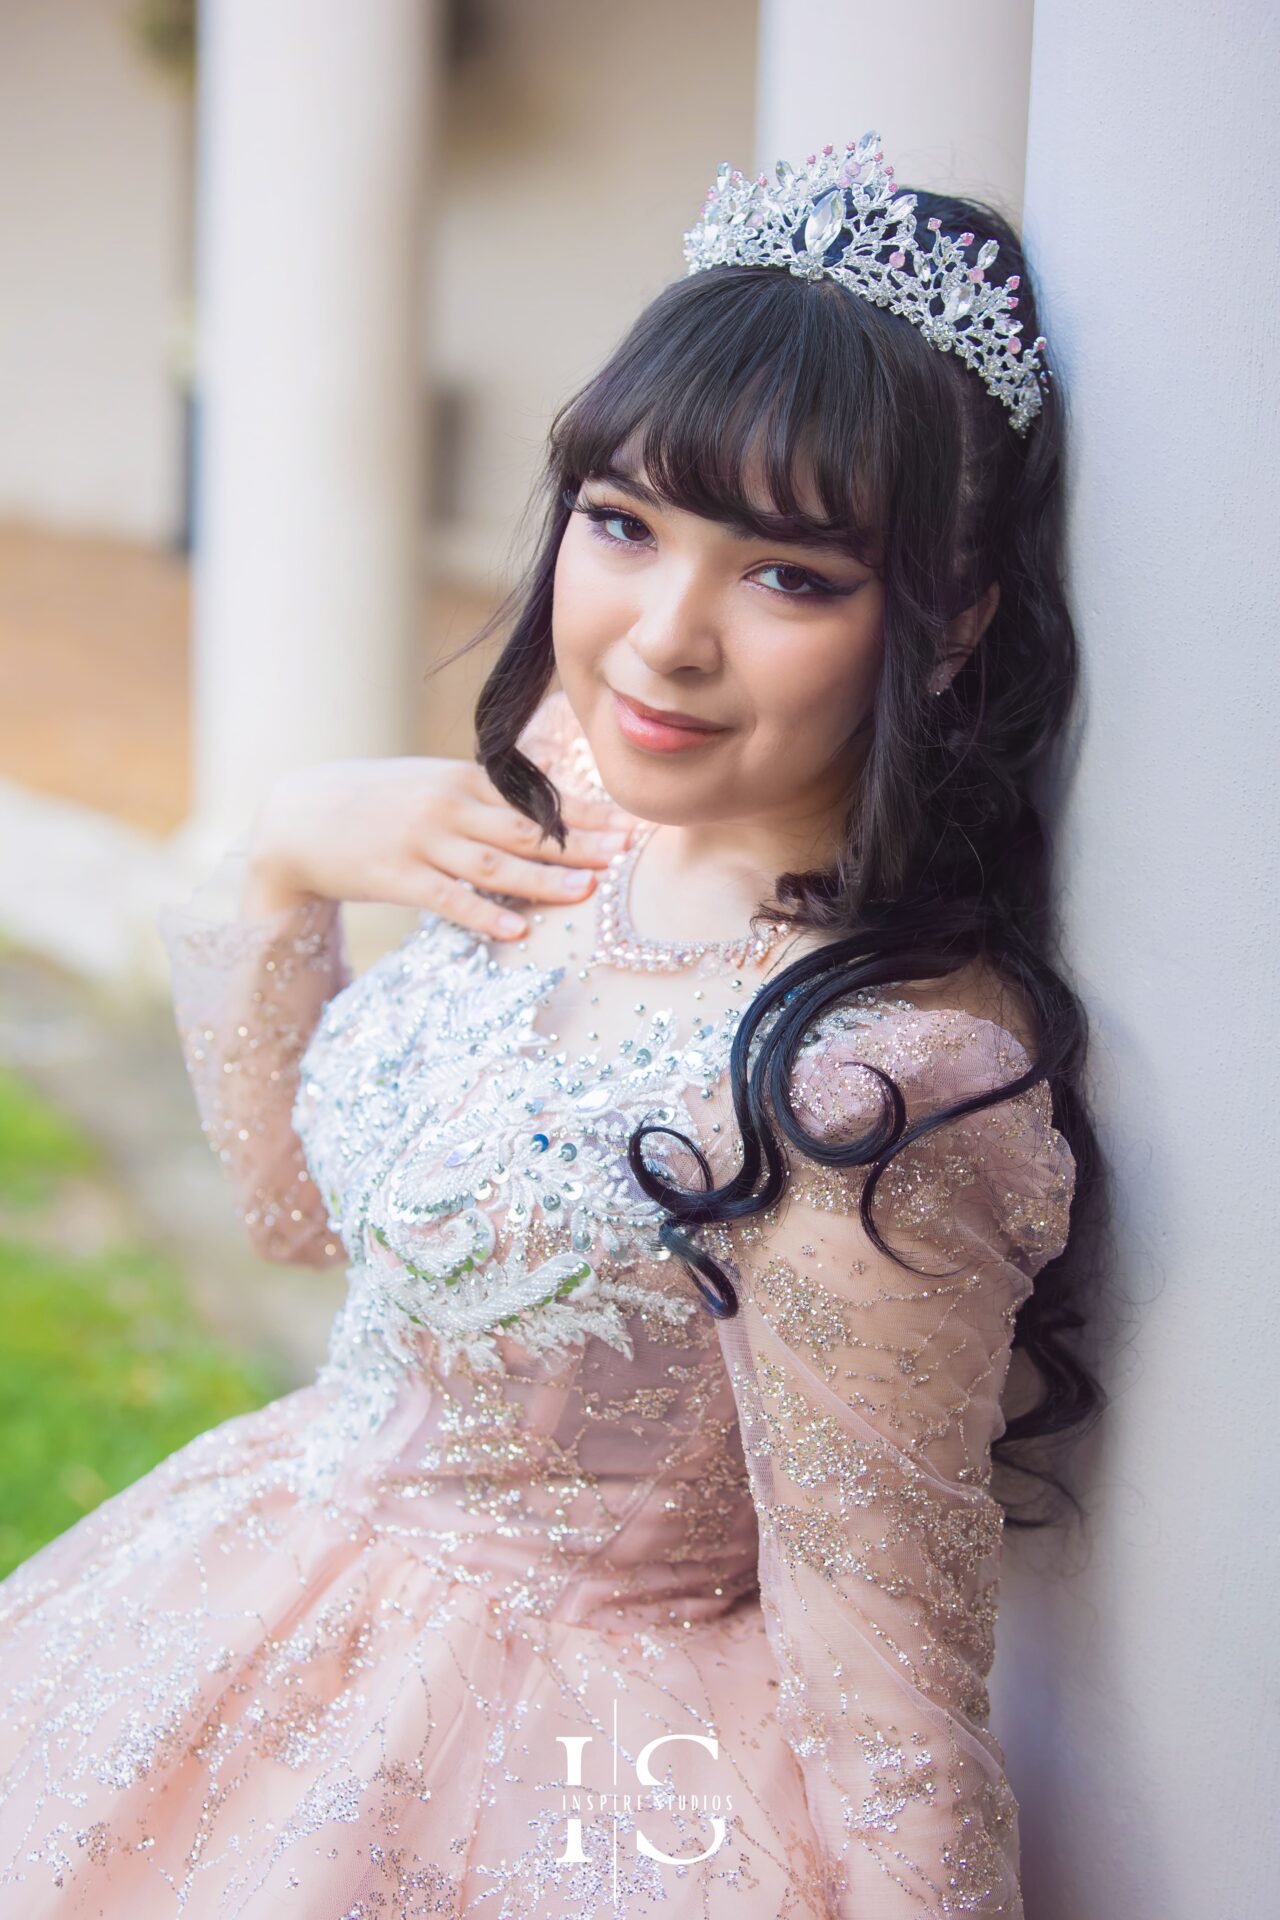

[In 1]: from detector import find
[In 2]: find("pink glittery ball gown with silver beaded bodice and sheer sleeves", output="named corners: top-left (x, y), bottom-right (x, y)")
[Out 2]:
top-left (0, 695), bottom-right (1075, 1920)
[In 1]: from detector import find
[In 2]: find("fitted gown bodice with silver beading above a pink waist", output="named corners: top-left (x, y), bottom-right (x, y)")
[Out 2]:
top-left (284, 898), bottom-right (771, 1619)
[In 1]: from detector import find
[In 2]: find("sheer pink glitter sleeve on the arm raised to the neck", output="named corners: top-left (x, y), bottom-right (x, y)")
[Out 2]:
top-left (157, 849), bottom-right (351, 1267)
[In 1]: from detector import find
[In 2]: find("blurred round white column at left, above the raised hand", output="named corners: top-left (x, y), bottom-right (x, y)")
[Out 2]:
top-left (186, 0), bottom-right (436, 851)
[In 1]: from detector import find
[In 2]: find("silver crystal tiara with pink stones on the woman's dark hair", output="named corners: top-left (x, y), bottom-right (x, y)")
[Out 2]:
top-left (685, 132), bottom-right (1052, 434)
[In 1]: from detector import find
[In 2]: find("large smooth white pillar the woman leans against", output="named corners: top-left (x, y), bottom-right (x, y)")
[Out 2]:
top-left (1002, 0), bottom-right (1280, 1920)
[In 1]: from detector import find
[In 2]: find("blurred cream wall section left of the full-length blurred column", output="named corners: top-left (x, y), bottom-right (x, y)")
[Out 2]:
top-left (0, 0), bottom-right (186, 540)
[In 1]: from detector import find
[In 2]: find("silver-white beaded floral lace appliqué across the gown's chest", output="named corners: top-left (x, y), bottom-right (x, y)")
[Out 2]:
top-left (292, 916), bottom-right (741, 1369)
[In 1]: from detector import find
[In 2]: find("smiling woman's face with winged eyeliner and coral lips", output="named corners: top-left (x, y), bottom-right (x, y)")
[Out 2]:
top-left (553, 441), bottom-right (883, 864)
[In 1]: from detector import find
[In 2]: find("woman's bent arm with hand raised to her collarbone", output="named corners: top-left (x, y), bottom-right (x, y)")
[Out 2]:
top-left (159, 693), bottom-right (629, 1267)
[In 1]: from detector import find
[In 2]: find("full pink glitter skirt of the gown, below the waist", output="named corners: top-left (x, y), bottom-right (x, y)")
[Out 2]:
top-left (0, 1386), bottom-right (829, 1920)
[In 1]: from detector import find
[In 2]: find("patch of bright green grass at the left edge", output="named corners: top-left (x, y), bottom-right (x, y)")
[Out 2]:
top-left (0, 1069), bottom-right (280, 1576)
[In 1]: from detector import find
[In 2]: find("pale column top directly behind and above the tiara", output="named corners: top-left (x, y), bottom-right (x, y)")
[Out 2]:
top-left (756, 0), bottom-right (1032, 225)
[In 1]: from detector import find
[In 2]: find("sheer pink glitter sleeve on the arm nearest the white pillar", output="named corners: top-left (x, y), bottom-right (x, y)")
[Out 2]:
top-left (708, 1010), bottom-right (1075, 1920)
